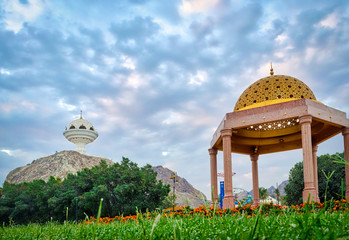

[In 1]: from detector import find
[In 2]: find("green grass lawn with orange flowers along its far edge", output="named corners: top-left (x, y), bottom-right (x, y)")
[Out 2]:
top-left (0, 200), bottom-right (349, 239)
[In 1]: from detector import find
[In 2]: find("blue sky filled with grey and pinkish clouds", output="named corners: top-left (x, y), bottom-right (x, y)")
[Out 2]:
top-left (0, 0), bottom-right (349, 197)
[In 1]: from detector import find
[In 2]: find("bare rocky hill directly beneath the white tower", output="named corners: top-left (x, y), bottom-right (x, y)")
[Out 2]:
top-left (6, 151), bottom-right (114, 184)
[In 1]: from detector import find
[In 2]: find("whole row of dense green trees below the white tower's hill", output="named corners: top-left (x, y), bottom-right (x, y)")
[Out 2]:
top-left (0, 158), bottom-right (170, 224)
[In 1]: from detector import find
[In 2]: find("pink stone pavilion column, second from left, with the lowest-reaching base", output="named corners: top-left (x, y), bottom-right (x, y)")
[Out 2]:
top-left (221, 129), bottom-right (235, 209)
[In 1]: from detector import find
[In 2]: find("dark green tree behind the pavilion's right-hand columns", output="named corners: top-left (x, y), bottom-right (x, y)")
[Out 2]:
top-left (285, 153), bottom-right (345, 205)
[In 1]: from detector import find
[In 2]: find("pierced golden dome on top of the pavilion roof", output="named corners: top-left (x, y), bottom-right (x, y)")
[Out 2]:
top-left (234, 75), bottom-right (316, 111)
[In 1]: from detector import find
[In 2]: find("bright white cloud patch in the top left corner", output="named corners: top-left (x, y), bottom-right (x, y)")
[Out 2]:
top-left (2, 0), bottom-right (44, 33)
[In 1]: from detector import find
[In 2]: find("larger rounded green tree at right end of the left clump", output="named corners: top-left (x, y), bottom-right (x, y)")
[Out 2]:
top-left (58, 158), bottom-right (170, 217)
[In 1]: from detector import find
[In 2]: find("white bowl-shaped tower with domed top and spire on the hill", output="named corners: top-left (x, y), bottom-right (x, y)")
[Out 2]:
top-left (63, 111), bottom-right (98, 154)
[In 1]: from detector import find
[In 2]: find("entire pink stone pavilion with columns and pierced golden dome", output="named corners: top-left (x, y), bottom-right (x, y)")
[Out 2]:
top-left (209, 68), bottom-right (349, 209)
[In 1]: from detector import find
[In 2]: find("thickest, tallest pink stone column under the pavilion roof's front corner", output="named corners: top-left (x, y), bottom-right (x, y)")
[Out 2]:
top-left (299, 115), bottom-right (316, 202)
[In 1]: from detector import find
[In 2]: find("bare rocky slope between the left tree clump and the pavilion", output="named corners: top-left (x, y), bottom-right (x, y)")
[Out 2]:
top-left (153, 166), bottom-right (206, 208)
